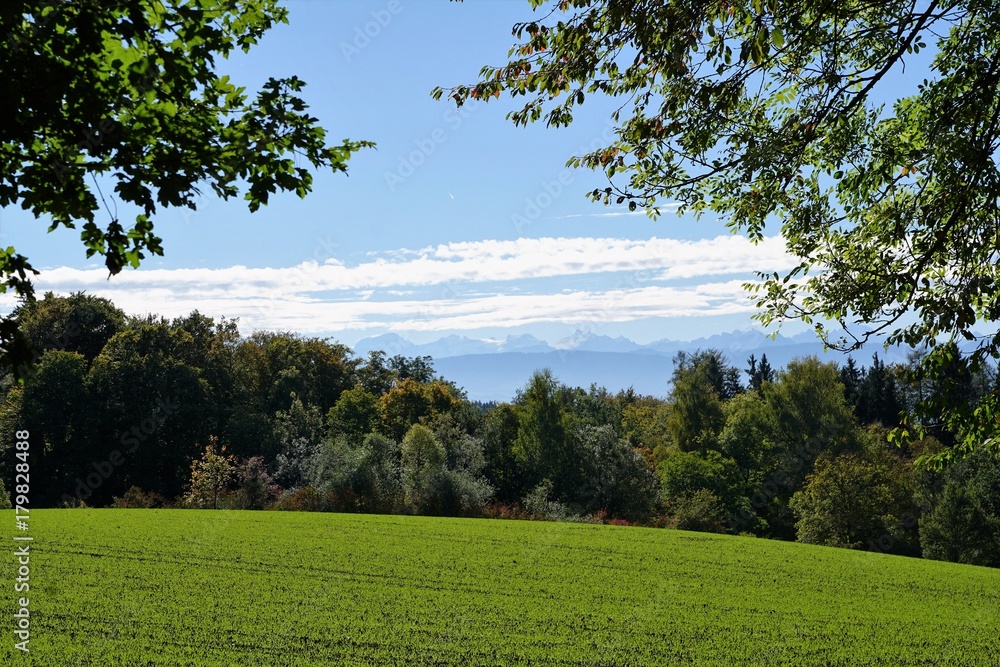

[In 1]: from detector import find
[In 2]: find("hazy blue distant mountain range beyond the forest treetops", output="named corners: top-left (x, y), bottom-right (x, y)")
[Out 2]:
top-left (354, 330), bottom-right (920, 401)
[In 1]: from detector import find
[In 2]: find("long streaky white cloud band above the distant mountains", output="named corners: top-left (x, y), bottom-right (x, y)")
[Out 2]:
top-left (0, 236), bottom-right (794, 333)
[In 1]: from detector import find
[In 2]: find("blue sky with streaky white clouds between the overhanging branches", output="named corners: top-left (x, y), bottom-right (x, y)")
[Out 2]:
top-left (0, 0), bottom-right (924, 344)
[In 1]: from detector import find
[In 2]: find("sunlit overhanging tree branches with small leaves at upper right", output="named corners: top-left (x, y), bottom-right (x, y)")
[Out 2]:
top-left (440, 0), bottom-right (1000, 460)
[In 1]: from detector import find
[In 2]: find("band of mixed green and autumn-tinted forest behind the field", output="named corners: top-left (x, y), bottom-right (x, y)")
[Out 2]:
top-left (0, 293), bottom-right (1000, 567)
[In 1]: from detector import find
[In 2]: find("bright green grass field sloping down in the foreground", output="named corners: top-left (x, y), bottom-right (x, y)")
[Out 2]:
top-left (0, 510), bottom-right (1000, 667)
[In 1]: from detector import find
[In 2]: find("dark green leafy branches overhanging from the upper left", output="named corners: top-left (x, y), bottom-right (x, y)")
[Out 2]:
top-left (0, 0), bottom-right (372, 376)
